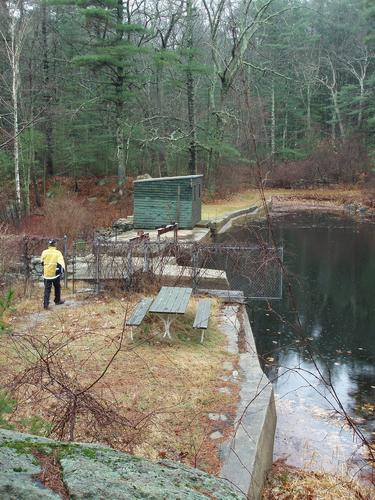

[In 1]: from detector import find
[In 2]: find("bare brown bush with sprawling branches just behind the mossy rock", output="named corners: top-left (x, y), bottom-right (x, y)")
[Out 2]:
top-left (5, 320), bottom-right (147, 451)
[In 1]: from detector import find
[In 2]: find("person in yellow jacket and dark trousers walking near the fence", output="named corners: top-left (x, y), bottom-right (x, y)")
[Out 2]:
top-left (40, 240), bottom-right (65, 309)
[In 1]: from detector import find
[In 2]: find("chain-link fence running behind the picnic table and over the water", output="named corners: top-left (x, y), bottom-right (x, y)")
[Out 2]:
top-left (4, 236), bottom-right (283, 299)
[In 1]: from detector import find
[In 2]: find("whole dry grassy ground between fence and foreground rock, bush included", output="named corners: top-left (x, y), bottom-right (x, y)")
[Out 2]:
top-left (0, 288), bottom-right (238, 473)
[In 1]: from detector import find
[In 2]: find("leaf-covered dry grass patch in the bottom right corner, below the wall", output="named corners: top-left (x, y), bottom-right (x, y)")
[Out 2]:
top-left (263, 460), bottom-right (375, 500)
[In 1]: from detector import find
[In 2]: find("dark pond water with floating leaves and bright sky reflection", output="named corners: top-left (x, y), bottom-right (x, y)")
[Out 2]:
top-left (217, 213), bottom-right (375, 472)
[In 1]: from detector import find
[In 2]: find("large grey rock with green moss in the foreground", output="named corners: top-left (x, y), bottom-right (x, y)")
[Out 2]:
top-left (0, 429), bottom-right (243, 500)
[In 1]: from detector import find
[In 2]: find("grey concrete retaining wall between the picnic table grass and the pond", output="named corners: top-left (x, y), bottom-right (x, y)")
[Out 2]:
top-left (221, 304), bottom-right (276, 500)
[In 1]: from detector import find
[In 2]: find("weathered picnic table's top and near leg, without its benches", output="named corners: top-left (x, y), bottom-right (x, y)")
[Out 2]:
top-left (149, 286), bottom-right (193, 339)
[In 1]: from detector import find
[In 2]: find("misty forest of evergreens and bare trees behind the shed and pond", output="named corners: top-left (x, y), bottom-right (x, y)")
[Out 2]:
top-left (0, 0), bottom-right (375, 223)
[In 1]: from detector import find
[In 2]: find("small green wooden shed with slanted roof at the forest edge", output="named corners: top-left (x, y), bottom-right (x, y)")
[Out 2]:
top-left (133, 175), bottom-right (203, 229)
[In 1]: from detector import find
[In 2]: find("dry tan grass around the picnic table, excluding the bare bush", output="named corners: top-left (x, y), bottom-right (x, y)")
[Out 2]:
top-left (0, 290), bottom-right (238, 473)
